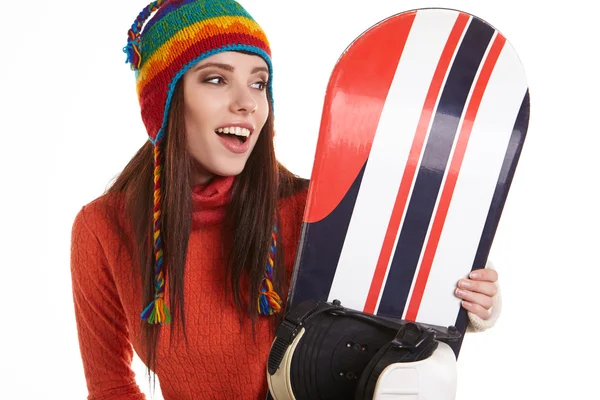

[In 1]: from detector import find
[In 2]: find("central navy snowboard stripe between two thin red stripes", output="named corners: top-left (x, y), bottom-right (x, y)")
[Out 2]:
top-left (377, 19), bottom-right (494, 318)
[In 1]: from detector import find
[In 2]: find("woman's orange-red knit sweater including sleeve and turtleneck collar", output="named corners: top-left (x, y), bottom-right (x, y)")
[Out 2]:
top-left (71, 179), bottom-right (306, 400)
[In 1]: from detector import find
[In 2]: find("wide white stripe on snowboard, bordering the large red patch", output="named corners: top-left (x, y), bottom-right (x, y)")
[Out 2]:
top-left (328, 8), bottom-right (458, 310)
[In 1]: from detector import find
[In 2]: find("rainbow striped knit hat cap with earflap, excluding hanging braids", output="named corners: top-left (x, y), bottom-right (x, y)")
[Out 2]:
top-left (123, 0), bottom-right (273, 144)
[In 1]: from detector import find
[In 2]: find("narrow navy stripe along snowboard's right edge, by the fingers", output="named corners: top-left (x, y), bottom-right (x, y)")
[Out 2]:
top-left (449, 90), bottom-right (529, 357)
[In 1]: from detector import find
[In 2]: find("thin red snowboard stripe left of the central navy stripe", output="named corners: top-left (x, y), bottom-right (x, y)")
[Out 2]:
top-left (364, 13), bottom-right (470, 314)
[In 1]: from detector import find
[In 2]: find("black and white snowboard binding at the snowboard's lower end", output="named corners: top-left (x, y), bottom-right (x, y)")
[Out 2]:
top-left (267, 300), bottom-right (461, 400)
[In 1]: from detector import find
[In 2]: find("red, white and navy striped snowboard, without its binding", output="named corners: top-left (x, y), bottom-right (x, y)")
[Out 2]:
top-left (286, 8), bottom-right (529, 358)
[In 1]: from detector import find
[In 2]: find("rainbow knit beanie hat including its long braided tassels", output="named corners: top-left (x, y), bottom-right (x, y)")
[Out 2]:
top-left (123, 0), bottom-right (281, 324)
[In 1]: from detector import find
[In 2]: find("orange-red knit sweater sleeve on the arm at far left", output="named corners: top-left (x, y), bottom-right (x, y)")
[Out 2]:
top-left (71, 207), bottom-right (145, 400)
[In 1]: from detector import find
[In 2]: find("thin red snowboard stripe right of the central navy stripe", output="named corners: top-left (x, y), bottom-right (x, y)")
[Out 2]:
top-left (405, 34), bottom-right (506, 321)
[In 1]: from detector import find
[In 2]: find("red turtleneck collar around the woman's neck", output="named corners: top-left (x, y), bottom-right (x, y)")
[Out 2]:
top-left (192, 176), bottom-right (234, 229)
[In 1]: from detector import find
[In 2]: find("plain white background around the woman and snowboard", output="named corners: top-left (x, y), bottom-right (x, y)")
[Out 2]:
top-left (0, 0), bottom-right (600, 400)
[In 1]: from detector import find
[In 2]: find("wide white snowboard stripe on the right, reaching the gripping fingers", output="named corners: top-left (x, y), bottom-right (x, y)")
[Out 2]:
top-left (417, 36), bottom-right (527, 326)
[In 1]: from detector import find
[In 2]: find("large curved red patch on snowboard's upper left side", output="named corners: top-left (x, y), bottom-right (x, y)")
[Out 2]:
top-left (304, 11), bottom-right (416, 223)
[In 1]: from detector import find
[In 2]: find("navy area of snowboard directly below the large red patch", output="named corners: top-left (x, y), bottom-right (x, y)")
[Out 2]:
top-left (286, 159), bottom-right (368, 310)
